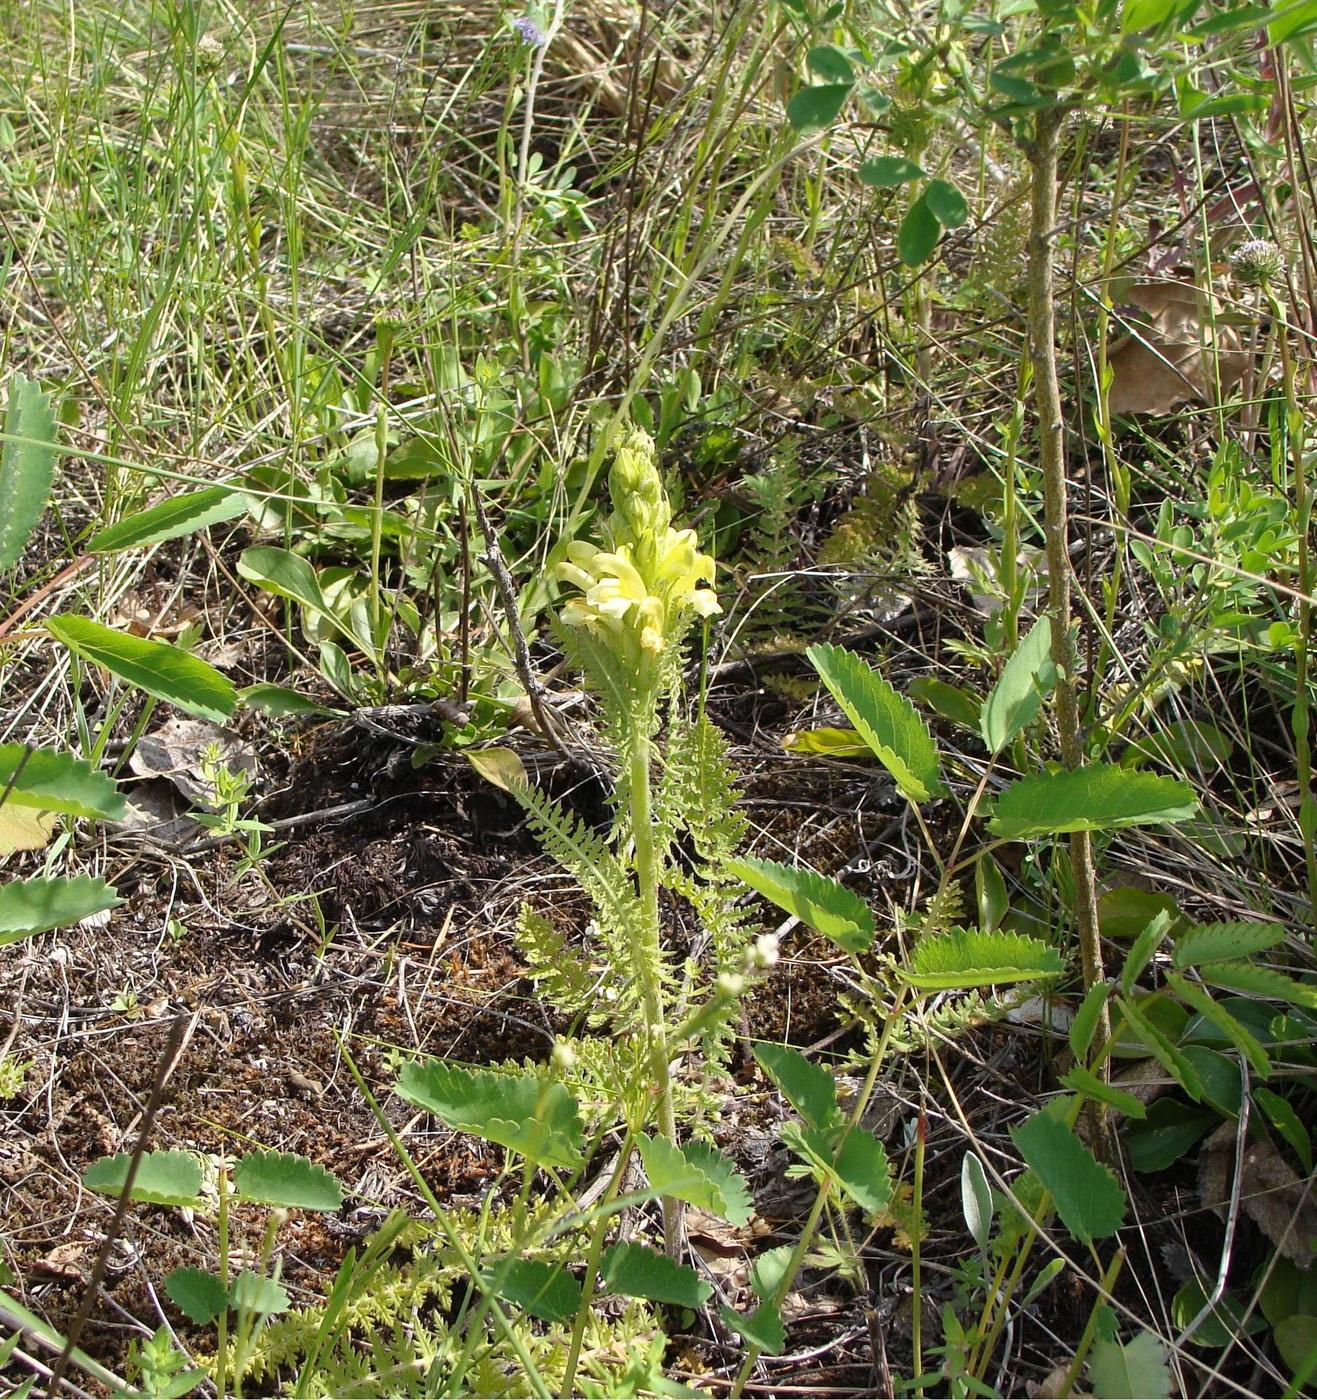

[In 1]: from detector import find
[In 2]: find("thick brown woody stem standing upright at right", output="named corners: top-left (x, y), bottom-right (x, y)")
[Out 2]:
top-left (1024, 108), bottom-right (1110, 1075)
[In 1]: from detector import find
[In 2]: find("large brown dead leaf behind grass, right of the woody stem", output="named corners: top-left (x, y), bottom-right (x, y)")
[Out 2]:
top-left (1108, 281), bottom-right (1248, 413)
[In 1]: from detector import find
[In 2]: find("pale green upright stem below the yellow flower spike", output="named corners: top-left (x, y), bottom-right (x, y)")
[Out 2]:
top-left (630, 720), bottom-right (682, 1259)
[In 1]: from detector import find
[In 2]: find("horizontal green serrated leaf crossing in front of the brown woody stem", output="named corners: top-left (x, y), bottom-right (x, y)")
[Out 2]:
top-left (988, 763), bottom-right (1198, 841)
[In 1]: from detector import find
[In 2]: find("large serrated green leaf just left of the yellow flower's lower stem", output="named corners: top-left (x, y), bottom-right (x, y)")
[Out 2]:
top-left (397, 1060), bottom-right (584, 1168)
